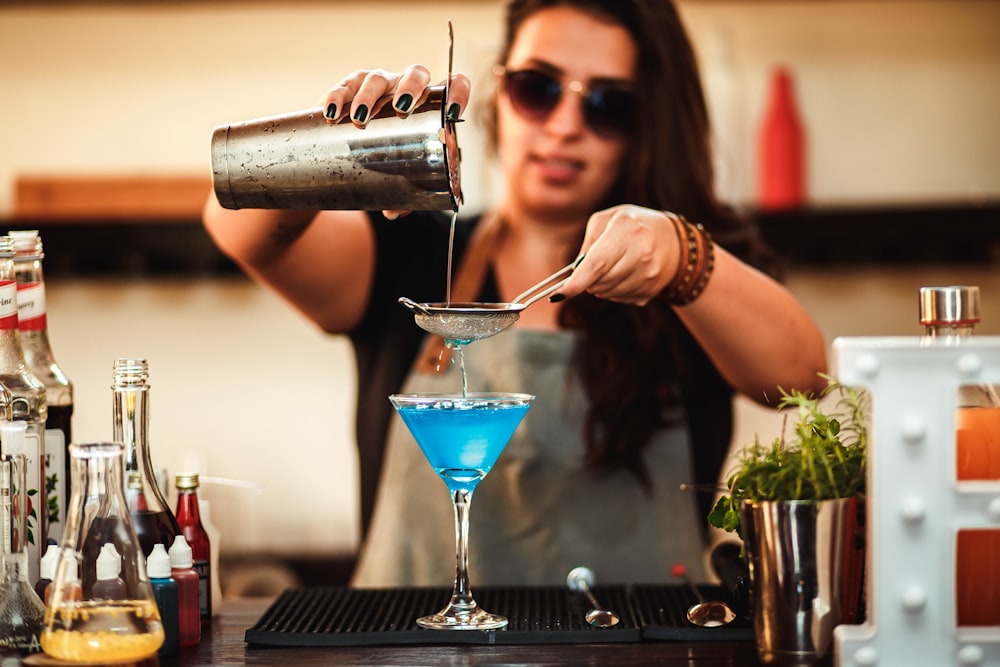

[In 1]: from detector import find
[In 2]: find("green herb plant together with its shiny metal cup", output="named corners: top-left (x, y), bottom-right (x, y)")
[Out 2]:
top-left (708, 378), bottom-right (868, 664)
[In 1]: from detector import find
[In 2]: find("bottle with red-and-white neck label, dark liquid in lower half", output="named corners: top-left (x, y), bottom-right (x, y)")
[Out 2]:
top-left (10, 230), bottom-right (73, 542)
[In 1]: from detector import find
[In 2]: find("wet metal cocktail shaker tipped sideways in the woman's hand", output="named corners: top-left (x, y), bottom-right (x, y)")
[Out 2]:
top-left (212, 86), bottom-right (462, 211)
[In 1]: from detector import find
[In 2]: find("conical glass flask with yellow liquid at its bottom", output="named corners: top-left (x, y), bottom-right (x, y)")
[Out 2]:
top-left (41, 442), bottom-right (163, 663)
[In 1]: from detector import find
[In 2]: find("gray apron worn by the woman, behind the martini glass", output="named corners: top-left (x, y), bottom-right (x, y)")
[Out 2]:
top-left (352, 326), bottom-right (706, 590)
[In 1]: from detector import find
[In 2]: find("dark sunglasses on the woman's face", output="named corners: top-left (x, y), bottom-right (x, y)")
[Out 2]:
top-left (493, 65), bottom-right (636, 139)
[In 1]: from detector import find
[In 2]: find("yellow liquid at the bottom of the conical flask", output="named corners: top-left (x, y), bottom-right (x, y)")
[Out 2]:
top-left (42, 600), bottom-right (163, 662)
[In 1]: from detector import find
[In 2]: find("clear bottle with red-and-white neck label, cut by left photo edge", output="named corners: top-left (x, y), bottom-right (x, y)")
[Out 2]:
top-left (0, 236), bottom-right (48, 581)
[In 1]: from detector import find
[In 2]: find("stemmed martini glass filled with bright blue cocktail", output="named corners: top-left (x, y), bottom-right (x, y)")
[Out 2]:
top-left (389, 392), bottom-right (535, 630)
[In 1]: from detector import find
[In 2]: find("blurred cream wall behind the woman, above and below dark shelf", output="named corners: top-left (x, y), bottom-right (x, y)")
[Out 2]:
top-left (0, 0), bottom-right (1000, 584)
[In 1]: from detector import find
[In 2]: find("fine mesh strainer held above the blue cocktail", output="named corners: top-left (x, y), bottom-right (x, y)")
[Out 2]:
top-left (399, 255), bottom-right (583, 345)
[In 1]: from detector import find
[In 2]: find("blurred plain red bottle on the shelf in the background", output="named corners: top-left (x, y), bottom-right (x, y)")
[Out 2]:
top-left (757, 67), bottom-right (806, 210)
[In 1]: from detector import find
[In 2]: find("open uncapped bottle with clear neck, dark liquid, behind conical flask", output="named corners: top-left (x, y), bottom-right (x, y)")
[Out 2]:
top-left (111, 358), bottom-right (181, 558)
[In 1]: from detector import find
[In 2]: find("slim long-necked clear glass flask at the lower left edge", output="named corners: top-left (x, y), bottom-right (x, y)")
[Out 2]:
top-left (0, 454), bottom-right (45, 653)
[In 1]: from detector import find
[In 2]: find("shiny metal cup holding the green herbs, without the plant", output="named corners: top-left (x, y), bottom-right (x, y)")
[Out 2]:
top-left (740, 498), bottom-right (864, 665)
